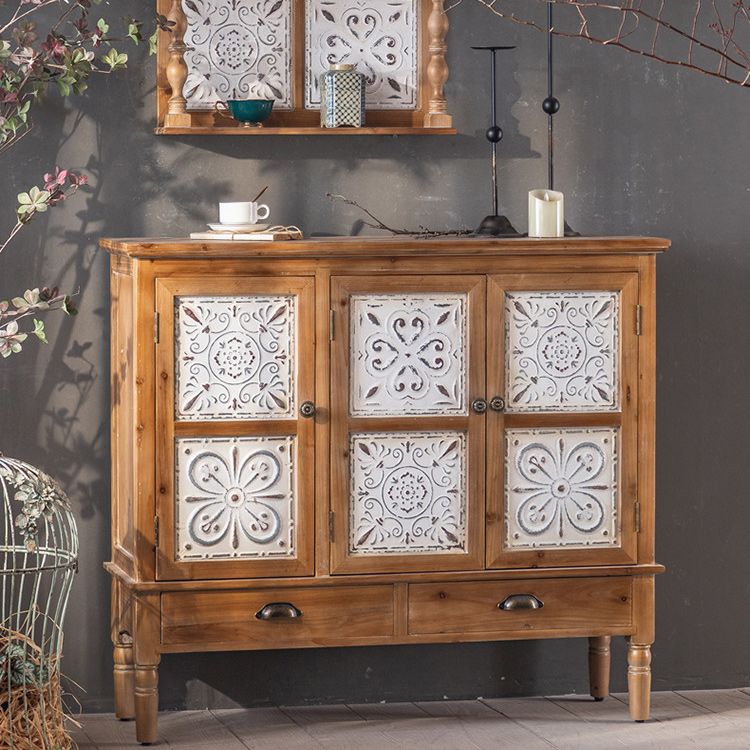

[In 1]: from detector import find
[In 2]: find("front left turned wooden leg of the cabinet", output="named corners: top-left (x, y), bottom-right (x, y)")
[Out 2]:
top-left (133, 593), bottom-right (161, 745)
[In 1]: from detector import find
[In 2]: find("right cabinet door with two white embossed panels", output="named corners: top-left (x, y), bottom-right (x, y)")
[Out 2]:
top-left (487, 273), bottom-right (638, 567)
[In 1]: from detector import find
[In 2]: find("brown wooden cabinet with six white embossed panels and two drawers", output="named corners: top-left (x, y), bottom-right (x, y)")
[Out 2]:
top-left (102, 238), bottom-right (669, 742)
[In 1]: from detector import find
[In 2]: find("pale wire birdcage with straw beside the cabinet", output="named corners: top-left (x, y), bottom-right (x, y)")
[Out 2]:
top-left (0, 456), bottom-right (78, 750)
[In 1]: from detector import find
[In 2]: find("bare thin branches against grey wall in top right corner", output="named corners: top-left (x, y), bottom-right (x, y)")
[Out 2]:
top-left (449, 0), bottom-right (750, 87)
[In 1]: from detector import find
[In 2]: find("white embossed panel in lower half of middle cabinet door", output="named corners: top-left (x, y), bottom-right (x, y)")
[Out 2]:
top-left (349, 432), bottom-right (467, 555)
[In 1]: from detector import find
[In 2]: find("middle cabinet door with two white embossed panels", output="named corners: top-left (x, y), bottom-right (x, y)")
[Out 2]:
top-left (331, 276), bottom-right (486, 573)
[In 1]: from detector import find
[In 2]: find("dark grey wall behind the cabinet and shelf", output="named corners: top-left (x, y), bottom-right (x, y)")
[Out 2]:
top-left (0, 0), bottom-right (750, 710)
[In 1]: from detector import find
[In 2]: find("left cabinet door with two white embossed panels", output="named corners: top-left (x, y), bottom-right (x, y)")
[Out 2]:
top-left (156, 277), bottom-right (315, 580)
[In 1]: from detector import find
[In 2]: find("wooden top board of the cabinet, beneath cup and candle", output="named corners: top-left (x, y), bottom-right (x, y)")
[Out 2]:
top-left (100, 236), bottom-right (671, 260)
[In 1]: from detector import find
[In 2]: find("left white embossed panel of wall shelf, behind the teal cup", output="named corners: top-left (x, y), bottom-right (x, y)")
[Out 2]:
top-left (182, 0), bottom-right (293, 110)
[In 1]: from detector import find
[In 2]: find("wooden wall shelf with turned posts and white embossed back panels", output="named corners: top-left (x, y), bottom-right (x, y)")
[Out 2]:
top-left (156, 0), bottom-right (456, 136)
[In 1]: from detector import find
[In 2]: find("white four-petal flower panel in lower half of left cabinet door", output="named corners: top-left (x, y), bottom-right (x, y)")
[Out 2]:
top-left (175, 437), bottom-right (295, 560)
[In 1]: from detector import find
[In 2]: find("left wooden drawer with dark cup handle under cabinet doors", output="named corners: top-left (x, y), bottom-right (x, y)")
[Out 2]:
top-left (162, 586), bottom-right (394, 650)
